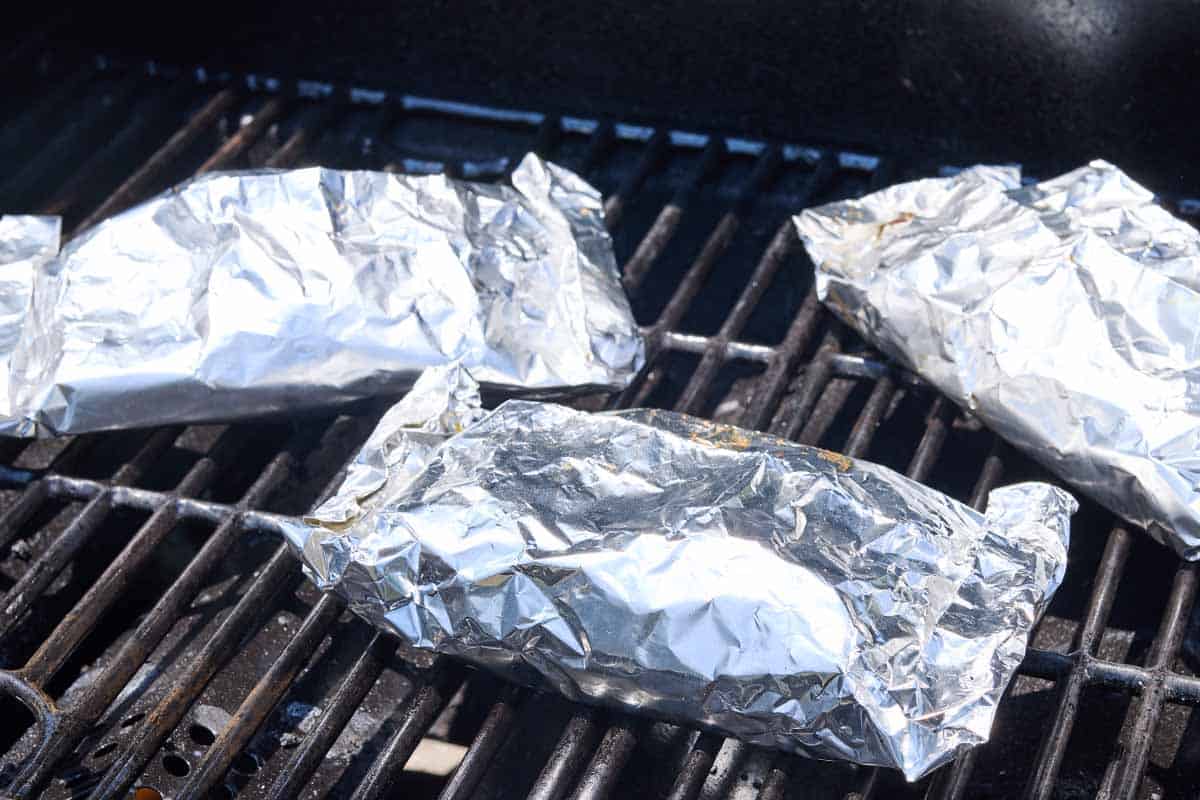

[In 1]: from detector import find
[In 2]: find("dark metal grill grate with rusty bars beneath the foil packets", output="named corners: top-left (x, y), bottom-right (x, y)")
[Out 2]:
top-left (0, 54), bottom-right (1200, 800)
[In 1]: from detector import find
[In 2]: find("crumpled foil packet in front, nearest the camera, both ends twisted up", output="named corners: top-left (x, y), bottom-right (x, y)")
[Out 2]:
top-left (284, 365), bottom-right (1075, 780)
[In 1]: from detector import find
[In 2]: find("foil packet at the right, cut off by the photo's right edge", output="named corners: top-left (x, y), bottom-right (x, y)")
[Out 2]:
top-left (796, 161), bottom-right (1200, 560)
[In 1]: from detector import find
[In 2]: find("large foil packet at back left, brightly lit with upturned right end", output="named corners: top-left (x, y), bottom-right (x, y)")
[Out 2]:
top-left (0, 155), bottom-right (643, 437)
